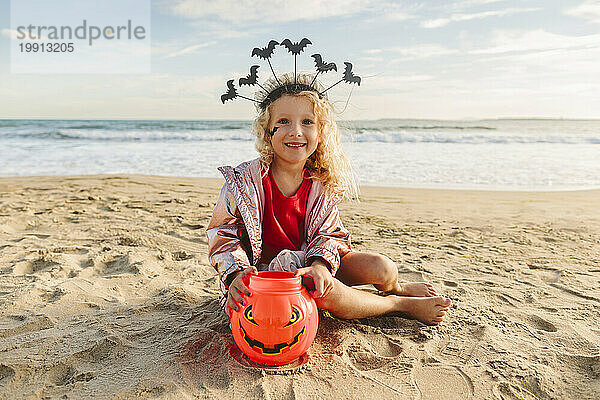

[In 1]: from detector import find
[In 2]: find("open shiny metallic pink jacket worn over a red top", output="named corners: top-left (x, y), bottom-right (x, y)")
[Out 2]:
top-left (206, 158), bottom-right (351, 305)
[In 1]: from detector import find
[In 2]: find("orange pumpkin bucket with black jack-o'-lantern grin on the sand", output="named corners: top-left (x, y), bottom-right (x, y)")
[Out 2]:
top-left (231, 271), bottom-right (319, 365)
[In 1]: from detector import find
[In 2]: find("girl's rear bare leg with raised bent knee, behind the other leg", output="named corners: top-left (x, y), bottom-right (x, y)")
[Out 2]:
top-left (335, 251), bottom-right (437, 297)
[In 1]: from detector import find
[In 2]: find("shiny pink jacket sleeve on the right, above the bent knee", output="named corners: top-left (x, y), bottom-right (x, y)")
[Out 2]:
top-left (305, 205), bottom-right (352, 275)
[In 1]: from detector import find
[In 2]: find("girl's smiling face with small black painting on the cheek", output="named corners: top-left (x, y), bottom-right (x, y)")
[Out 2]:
top-left (268, 95), bottom-right (319, 166)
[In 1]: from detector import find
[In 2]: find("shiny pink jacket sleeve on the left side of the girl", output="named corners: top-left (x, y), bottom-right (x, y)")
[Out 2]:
top-left (206, 183), bottom-right (250, 303)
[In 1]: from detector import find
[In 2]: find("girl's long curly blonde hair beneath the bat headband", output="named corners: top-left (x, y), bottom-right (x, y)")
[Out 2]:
top-left (252, 74), bottom-right (359, 201)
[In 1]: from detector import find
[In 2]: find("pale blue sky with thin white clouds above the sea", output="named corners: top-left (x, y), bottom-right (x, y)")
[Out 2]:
top-left (0, 0), bottom-right (600, 120)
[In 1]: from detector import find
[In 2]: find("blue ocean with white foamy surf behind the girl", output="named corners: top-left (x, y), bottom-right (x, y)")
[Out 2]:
top-left (0, 119), bottom-right (600, 190)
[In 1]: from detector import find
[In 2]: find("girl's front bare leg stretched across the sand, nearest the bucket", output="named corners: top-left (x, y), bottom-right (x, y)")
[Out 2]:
top-left (315, 278), bottom-right (450, 325)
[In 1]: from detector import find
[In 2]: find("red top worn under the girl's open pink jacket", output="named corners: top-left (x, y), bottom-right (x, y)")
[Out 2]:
top-left (260, 169), bottom-right (312, 264)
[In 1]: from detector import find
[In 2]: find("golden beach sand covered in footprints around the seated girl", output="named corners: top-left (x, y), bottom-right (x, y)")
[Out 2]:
top-left (0, 175), bottom-right (600, 400)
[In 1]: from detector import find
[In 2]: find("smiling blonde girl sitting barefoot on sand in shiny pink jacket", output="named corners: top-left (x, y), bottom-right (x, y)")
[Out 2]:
top-left (207, 75), bottom-right (450, 324)
